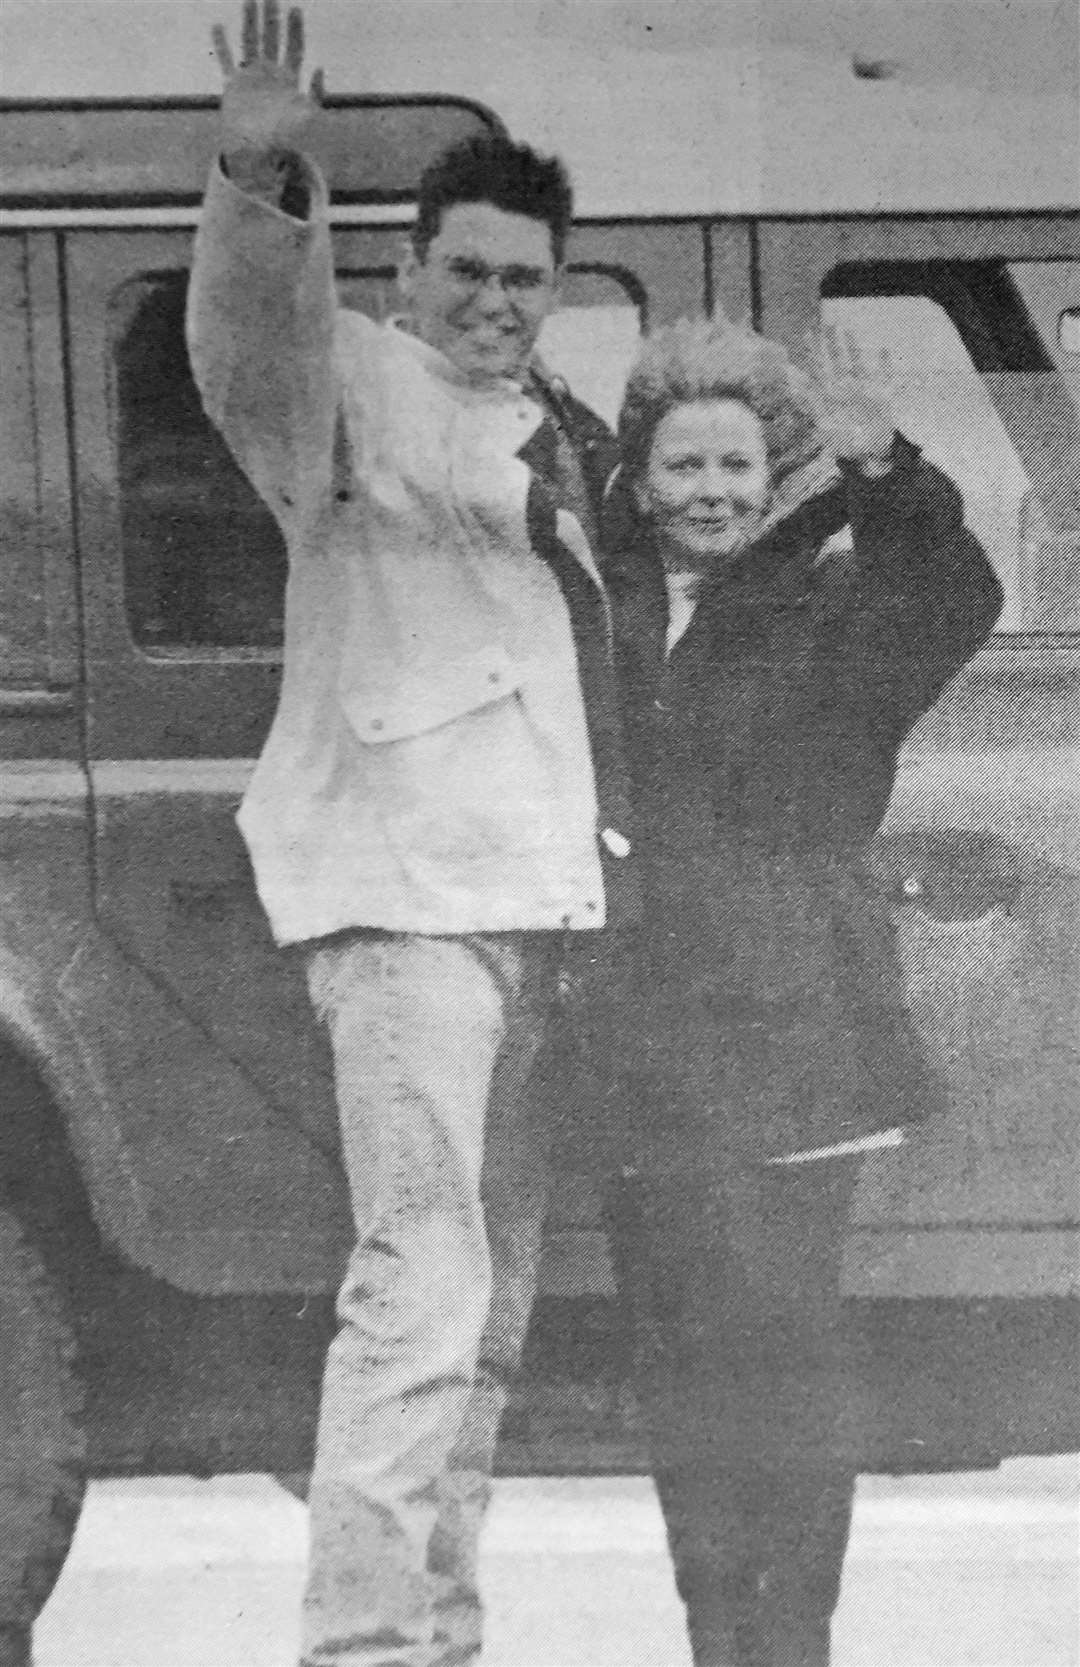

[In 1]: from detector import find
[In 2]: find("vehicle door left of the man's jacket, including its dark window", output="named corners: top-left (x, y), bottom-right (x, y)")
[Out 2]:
top-left (67, 228), bottom-right (335, 1147)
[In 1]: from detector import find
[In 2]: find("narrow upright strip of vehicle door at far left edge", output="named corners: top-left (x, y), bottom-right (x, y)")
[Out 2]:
top-left (0, 230), bottom-right (88, 1026)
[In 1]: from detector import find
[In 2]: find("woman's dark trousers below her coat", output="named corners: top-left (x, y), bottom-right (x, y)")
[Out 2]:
top-left (617, 1159), bottom-right (857, 1667)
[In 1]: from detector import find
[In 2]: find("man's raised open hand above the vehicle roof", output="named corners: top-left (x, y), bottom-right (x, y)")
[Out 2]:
top-left (212, 0), bottom-right (323, 190)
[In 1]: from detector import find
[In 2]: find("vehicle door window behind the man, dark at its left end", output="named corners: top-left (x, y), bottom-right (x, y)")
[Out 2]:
top-left (108, 267), bottom-right (645, 658)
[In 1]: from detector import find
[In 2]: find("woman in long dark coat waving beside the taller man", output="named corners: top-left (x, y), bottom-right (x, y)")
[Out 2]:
top-left (607, 323), bottom-right (1002, 1667)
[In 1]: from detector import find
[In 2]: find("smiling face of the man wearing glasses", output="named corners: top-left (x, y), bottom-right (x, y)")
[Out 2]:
top-left (400, 203), bottom-right (558, 383)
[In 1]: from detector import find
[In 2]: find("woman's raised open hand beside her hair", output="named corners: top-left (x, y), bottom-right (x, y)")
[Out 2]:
top-left (808, 325), bottom-right (897, 477)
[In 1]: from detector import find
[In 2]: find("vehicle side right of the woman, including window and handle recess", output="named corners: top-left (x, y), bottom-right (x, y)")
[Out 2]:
top-left (757, 213), bottom-right (1080, 1299)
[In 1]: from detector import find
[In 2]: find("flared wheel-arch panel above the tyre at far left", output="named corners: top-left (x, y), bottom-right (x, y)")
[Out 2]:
top-left (0, 760), bottom-right (348, 1295)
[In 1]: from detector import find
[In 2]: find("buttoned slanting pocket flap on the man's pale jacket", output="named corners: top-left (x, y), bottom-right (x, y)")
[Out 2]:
top-left (340, 645), bottom-right (522, 747)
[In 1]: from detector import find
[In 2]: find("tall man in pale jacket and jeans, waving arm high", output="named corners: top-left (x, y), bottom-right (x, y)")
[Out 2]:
top-left (188, 0), bottom-right (633, 1667)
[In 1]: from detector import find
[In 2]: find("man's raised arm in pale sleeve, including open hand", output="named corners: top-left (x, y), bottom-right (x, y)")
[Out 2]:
top-left (187, 0), bottom-right (337, 522)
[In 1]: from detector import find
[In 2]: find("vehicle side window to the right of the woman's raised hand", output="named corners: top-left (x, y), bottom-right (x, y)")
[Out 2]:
top-left (822, 260), bottom-right (1080, 633)
